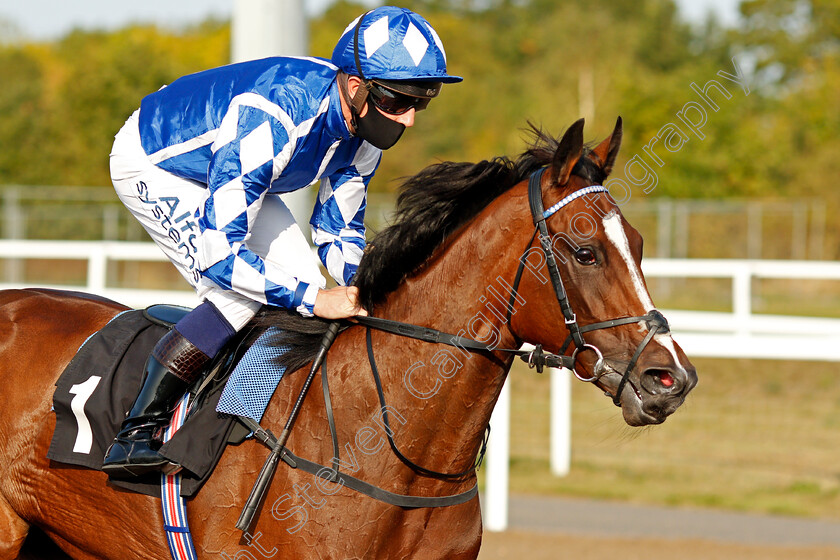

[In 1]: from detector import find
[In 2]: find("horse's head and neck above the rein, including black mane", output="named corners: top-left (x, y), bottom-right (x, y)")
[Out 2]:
top-left (356, 119), bottom-right (697, 426)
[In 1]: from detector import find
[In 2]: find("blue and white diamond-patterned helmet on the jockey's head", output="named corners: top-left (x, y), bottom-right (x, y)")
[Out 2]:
top-left (332, 6), bottom-right (463, 83)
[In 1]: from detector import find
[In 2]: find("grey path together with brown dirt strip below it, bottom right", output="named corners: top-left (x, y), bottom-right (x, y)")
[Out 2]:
top-left (478, 496), bottom-right (840, 560)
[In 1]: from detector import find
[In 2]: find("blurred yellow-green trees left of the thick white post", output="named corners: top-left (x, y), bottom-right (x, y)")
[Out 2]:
top-left (0, 21), bottom-right (230, 185)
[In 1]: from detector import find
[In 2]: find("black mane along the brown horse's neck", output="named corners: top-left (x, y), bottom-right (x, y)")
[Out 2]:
top-left (255, 123), bottom-right (606, 372)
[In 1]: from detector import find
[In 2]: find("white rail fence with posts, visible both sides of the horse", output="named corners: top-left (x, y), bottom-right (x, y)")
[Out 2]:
top-left (0, 240), bottom-right (840, 531)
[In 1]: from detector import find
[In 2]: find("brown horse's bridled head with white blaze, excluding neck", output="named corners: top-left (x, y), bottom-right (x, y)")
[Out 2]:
top-left (511, 118), bottom-right (697, 426)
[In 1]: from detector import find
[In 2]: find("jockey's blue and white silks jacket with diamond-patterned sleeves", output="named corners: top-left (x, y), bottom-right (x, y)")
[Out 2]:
top-left (138, 58), bottom-right (381, 314)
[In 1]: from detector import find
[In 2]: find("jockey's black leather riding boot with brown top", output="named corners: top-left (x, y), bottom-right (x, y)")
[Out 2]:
top-left (102, 329), bottom-right (209, 478)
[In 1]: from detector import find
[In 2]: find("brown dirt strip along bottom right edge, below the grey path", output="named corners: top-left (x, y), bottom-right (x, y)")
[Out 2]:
top-left (478, 530), bottom-right (840, 560)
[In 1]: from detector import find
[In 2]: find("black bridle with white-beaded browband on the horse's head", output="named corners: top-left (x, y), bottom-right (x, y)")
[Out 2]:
top-left (507, 168), bottom-right (670, 407)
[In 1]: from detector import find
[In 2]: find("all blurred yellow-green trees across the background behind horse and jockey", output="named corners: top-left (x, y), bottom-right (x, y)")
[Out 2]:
top-left (0, 0), bottom-right (840, 218)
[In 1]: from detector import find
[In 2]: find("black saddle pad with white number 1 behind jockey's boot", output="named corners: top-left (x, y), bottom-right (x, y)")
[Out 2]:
top-left (47, 310), bottom-right (244, 497)
